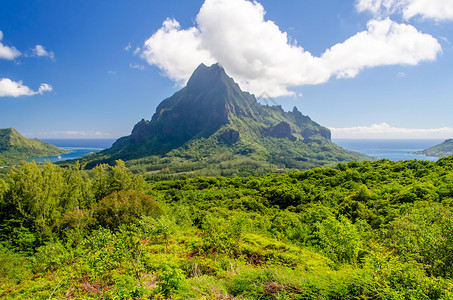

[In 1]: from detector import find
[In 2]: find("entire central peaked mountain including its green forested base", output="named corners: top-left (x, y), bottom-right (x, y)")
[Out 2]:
top-left (77, 64), bottom-right (369, 175)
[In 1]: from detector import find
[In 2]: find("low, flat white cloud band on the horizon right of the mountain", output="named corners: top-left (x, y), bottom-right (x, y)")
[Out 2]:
top-left (330, 123), bottom-right (453, 139)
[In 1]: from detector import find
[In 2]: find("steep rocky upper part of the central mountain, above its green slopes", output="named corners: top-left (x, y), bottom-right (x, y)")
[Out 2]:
top-left (122, 64), bottom-right (330, 154)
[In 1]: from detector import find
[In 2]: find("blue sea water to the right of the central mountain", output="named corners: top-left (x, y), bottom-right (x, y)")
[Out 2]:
top-left (332, 139), bottom-right (443, 161)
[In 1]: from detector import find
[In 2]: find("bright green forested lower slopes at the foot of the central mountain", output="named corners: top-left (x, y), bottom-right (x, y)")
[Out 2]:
top-left (88, 137), bottom-right (365, 180)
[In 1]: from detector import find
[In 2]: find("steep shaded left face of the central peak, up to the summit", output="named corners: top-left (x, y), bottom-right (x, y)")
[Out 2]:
top-left (114, 64), bottom-right (264, 154)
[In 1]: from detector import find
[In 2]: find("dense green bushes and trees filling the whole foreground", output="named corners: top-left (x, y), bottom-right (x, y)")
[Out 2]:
top-left (0, 157), bottom-right (453, 299)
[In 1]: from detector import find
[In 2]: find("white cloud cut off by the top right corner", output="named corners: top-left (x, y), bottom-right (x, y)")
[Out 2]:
top-left (356, 0), bottom-right (453, 21)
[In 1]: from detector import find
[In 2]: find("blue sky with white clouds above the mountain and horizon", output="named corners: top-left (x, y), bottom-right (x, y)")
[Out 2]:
top-left (0, 0), bottom-right (453, 138)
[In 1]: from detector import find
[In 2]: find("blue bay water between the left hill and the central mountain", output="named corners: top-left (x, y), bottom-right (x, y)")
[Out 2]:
top-left (27, 139), bottom-right (115, 162)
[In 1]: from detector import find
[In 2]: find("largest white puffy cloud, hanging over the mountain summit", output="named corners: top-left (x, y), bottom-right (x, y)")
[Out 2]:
top-left (141, 0), bottom-right (442, 97)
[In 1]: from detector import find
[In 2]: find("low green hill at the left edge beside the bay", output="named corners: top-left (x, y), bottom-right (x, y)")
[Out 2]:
top-left (0, 128), bottom-right (67, 166)
